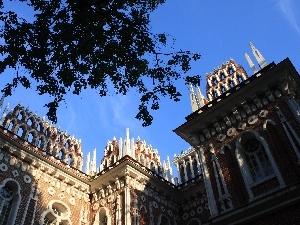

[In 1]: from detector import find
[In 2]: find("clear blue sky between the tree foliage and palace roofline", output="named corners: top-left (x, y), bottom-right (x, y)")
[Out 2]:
top-left (0, 0), bottom-right (300, 175)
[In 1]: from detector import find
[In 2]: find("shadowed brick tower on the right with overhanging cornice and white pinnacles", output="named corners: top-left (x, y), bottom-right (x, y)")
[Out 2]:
top-left (174, 43), bottom-right (300, 224)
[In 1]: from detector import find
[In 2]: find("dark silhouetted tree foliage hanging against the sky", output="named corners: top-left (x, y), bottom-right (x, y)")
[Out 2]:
top-left (0, 0), bottom-right (200, 126)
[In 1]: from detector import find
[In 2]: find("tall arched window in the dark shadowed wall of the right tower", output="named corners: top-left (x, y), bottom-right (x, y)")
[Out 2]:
top-left (238, 131), bottom-right (274, 183)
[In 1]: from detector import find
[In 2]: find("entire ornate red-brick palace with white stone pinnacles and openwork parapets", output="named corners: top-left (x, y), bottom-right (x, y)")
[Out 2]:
top-left (0, 43), bottom-right (300, 225)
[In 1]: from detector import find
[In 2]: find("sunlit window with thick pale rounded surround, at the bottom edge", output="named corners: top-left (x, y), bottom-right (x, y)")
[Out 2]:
top-left (41, 200), bottom-right (72, 225)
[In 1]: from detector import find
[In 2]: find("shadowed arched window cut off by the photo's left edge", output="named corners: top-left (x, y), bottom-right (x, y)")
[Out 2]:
top-left (0, 180), bottom-right (21, 225)
